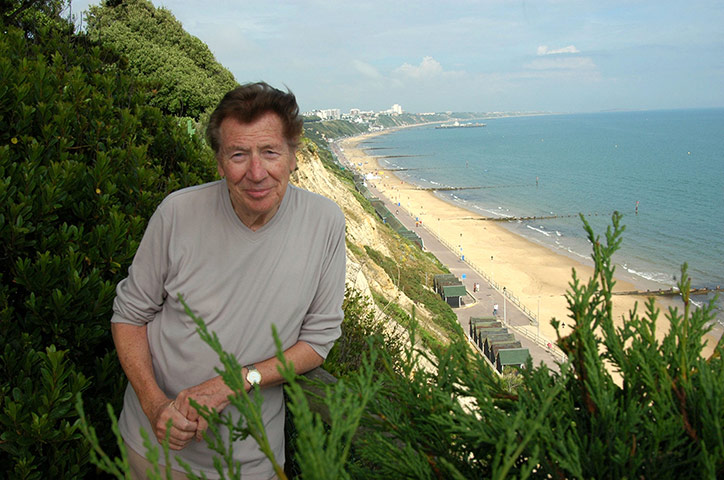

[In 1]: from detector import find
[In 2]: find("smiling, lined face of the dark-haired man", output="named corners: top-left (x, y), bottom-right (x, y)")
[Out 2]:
top-left (217, 112), bottom-right (297, 230)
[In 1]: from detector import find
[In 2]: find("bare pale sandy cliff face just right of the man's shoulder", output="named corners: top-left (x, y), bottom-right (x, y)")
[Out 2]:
top-left (291, 144), bottom-right (428, 322)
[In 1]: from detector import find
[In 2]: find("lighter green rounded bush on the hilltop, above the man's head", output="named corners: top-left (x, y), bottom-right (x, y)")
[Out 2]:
top-left (87, 0), bottom-right (236, 118)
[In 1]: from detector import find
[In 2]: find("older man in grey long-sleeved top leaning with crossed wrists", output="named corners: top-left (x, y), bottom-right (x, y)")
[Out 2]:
top-left (112, 83), bottom-right (345, 480)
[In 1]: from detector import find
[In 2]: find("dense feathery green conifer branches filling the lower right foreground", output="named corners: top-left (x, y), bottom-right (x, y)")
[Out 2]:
top-left (78, 216), bottom-right (724, 480)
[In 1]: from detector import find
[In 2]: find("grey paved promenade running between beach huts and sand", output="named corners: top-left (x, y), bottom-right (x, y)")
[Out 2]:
top-left (362, 179), bottom-right (564, 371)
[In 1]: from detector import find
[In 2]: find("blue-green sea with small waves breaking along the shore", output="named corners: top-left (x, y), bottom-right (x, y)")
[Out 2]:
top-left (360, 109), bottom-right (724, 323)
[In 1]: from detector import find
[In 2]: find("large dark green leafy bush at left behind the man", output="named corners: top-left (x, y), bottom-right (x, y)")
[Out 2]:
top-left (0, 17), bottom-right (215, 478)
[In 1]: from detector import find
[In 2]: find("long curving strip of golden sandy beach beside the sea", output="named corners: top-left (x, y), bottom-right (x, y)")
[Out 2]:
top-left (339, 130), bottom-right (721, 355)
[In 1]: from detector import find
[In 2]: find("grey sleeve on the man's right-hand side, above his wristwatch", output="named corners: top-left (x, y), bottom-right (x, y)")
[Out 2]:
top-left (299, 205), bottom-right (347, 358)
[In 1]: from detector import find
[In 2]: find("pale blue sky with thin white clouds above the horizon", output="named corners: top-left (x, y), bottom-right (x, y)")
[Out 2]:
top-left (73, 0), bottom-right (724, 113)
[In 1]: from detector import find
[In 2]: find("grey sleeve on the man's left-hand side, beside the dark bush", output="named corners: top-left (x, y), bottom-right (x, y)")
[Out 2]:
top-left (111, 207), bottom-right (170, 326)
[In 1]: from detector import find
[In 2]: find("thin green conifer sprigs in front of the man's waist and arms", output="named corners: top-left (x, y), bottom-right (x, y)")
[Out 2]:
top-left (76, 298), bottom-right (381, 480)
